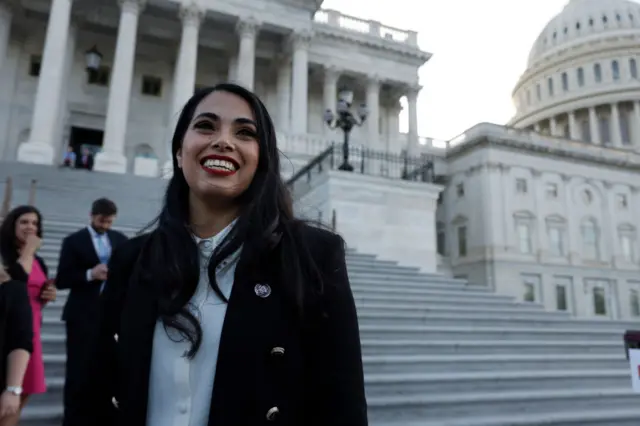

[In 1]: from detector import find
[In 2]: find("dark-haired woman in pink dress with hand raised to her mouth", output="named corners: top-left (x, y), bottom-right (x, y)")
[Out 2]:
top-left (0, 206), bottom-right (56, 422)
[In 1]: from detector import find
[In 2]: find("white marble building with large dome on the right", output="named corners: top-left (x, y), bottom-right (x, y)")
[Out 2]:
top-left (437, 0), bottom-right (640, 319)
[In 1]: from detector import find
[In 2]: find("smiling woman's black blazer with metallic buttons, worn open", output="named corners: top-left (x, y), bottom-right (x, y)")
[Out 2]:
top-left (80, 226), bottom-right (368, 426)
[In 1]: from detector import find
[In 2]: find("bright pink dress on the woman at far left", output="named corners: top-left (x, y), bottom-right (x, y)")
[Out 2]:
top-left (22, 260), bottom-right (47, 395)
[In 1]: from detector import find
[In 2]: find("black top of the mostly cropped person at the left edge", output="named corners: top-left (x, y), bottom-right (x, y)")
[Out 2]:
top-left (0, 280), bottom-right (33, 389)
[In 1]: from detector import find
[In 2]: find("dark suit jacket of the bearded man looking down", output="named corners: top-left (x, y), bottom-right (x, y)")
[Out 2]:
top-left (56, 228), bottom-right (127, 321)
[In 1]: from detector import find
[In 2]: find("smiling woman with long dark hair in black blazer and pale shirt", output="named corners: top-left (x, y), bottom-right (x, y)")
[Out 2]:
top-left (82, 84), bottom-right (367, 426)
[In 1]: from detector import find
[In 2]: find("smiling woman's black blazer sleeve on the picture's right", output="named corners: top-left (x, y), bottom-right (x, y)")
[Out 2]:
top-left (305, 233), bottom-right (368, 426)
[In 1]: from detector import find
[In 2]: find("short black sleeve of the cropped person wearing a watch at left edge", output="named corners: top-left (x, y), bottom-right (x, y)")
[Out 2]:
top-left (2, 280), bottom-right (33, 353)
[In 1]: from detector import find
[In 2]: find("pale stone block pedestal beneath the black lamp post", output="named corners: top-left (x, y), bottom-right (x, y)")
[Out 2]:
top-left (294, 170), bottom-right (442, 273)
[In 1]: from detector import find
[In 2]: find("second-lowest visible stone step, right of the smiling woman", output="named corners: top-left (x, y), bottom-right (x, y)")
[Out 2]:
top-left (367, 387), bottom-right (638, 425)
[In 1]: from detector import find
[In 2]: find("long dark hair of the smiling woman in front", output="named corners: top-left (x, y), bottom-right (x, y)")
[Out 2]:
top-left (134, 83), bottom-right (321, 357)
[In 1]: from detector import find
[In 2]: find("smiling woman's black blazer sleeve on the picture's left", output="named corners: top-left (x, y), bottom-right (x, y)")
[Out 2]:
top-left (81, 238), bottom-right (134, 426)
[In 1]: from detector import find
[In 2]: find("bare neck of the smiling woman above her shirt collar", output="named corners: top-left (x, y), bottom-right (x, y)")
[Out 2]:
top-left (189, 196), bottom-right (239, 238)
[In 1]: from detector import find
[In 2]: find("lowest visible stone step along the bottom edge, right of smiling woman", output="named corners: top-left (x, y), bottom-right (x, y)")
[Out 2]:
top-left (371, 406), bottom-right (640, 426)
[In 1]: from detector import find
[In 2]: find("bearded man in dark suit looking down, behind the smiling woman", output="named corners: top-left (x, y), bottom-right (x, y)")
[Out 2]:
top-left (56, 198), bottom-right (127, 426)
